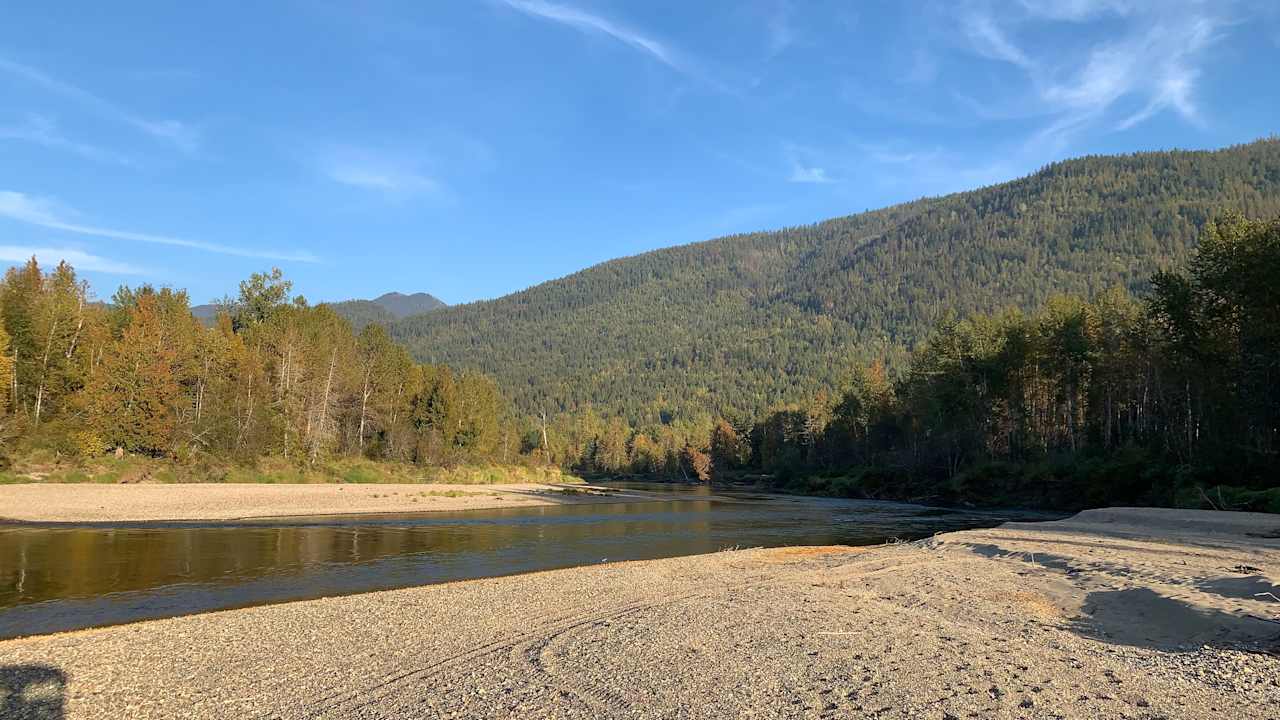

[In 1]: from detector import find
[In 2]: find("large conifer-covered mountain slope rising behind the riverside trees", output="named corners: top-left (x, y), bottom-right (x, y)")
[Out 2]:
top-left (392, 140), bottom-right (1280, 425)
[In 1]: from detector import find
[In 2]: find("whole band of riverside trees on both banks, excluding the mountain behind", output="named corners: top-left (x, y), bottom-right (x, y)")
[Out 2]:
top-left (0, 208), bottom-right (1280, 511)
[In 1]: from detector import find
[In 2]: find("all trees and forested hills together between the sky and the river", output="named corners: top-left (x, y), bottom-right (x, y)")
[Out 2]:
top-left (0, 140), bottom-right (1280, 511)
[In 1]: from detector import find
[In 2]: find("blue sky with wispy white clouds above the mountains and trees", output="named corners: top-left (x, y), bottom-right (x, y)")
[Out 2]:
top-left (0, 0), bottom-right (1280, 302)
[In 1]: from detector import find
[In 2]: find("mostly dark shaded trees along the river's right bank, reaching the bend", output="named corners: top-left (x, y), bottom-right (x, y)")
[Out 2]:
top-left (554, 215), bottom-right (1280, 511)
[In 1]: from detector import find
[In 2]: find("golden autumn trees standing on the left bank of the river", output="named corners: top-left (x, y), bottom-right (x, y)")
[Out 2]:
top-left (0, 259), bottom-right (518, 465)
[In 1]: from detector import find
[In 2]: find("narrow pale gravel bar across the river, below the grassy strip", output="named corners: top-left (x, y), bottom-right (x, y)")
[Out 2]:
top-left (0, 483), bottom-right (648, 523)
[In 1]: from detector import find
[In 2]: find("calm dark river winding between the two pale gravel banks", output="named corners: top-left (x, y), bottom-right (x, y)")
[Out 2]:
top-left (0, 484), bottom-right (1046, 639)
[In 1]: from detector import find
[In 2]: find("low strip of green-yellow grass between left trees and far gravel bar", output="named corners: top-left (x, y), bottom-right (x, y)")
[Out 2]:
top-left (0, 452), bottom-right (582, 486)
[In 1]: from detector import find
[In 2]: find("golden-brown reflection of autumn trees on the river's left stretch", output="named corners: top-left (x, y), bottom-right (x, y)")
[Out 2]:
top-left (0, 501), bottom-right (719, 607)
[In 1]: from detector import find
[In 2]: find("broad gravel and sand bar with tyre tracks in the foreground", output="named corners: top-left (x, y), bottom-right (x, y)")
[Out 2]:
top-left (0, 510), bottom-right (1280, 719)
